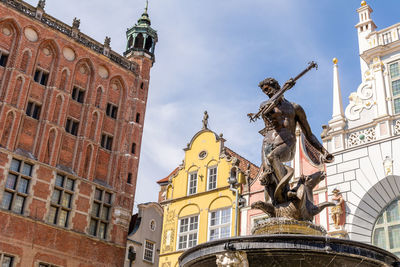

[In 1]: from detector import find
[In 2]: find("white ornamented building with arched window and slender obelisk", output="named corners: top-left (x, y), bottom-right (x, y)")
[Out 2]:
top-left (322, 1), bottom-right (400, 256)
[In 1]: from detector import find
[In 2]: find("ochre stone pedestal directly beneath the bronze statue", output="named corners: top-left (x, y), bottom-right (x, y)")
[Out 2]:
top-left (251, 218), bottom-right (327, 236)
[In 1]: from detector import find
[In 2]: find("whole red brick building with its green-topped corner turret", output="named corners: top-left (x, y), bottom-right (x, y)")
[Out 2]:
top-left (0, 0), bottom-right (157, 267)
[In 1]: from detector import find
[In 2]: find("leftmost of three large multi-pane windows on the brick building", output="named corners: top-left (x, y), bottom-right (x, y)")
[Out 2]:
top-left (1, 159), bottom-right (33, 214)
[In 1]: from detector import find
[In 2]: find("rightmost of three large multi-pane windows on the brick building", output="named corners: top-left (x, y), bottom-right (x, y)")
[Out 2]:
top-left (89, 188), bottom-right (112, 239)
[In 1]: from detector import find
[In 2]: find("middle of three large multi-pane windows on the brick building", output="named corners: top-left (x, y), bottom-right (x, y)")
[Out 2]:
top-left (49, 174), bottom-right (75, 227)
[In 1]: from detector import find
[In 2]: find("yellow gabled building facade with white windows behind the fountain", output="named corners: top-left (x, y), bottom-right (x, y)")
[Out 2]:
top-left (158, 127), bottom-right (251, 267)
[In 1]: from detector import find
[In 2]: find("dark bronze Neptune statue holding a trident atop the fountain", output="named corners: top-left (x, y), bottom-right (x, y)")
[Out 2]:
top-left (248, 62), bottom-right (334, 221)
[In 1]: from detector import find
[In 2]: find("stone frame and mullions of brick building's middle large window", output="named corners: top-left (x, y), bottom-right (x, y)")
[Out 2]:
top-left (47, 173), bottom-right (76, 228)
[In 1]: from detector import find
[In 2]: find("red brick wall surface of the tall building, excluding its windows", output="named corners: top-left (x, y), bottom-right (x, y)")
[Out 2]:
top-left (0, 3), bottom-right (152, 267)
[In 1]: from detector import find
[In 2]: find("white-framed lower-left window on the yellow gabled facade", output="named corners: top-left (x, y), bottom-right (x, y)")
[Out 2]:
top-left (178, 215), bottom-right (199, 249)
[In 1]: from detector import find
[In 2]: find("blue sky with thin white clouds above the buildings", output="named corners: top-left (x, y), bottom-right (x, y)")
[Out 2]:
top-left (27, 0), bottom-right (400, 211)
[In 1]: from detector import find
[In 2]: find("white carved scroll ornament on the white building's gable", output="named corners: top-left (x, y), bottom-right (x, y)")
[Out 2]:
top-left (345, 81), bottom-right (376, 121)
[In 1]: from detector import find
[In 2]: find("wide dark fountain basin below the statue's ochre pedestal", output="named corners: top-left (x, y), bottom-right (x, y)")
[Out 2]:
top-left (179, 234), bottom-right (400, 267)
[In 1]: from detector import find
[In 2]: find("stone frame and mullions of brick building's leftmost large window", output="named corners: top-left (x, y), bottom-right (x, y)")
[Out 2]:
top-left (1, 158), bottom-right (35, 214)
